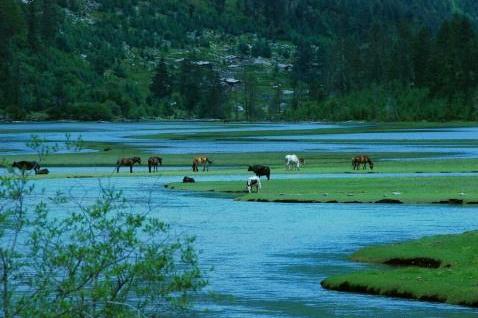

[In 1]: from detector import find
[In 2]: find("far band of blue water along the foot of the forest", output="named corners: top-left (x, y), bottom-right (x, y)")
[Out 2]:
top-left (0, 122), bottom-right (478, 158)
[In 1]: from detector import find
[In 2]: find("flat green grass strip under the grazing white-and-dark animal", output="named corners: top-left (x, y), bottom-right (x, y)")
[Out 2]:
top-left (169, 175), bottom-right (478, 203)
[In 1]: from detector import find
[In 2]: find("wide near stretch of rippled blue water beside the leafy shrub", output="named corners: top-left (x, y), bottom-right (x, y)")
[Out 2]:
top-left (30, 177), bottom-right (478, 317)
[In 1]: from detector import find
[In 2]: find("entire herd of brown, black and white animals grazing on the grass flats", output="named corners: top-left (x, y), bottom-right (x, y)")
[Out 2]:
top-left (12, 154), bottom-right (373, 193)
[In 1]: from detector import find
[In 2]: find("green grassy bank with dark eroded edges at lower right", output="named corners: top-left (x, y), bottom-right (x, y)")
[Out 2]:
top-left (322, 232), bottom-right (478, 307)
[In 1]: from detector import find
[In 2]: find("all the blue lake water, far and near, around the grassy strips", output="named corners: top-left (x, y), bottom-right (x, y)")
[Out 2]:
top-left (5, 122), bottom-right (478, 318)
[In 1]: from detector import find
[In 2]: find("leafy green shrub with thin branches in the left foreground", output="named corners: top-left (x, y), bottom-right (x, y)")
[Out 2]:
top-left (0, 170), bottom-right (205, 318)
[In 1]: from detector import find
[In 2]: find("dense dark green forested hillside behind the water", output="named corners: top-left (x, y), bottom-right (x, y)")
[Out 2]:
top-left (0, 0), bottom-right (478, 121)
